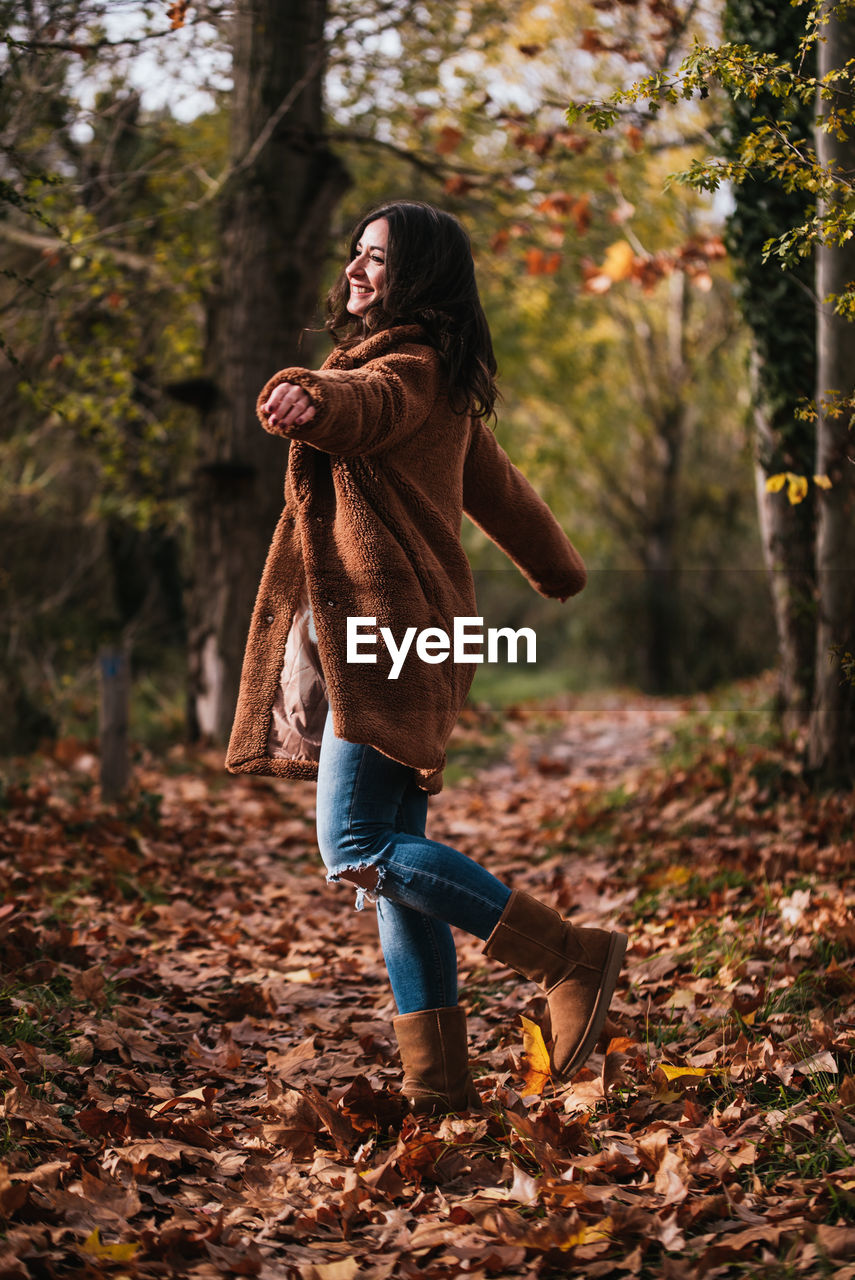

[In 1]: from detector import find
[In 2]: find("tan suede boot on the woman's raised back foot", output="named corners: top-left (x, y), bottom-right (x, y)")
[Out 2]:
top-left (484, 890), bottom-right (627, 1076)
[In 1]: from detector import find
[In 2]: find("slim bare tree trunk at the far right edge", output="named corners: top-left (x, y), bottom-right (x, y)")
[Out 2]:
top-left (808, 8), bottom-right (855, 786)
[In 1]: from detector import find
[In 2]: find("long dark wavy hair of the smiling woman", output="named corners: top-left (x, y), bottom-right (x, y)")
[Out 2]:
top-left (326, 200), bottom-right (499, 419)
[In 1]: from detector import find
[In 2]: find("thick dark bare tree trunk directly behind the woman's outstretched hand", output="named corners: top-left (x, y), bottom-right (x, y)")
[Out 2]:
top-left (188, 0), bottom-right (348, 741)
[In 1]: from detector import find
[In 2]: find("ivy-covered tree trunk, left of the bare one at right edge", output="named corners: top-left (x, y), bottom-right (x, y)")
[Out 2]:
top-left (724, 0), bottom-right (817, 731)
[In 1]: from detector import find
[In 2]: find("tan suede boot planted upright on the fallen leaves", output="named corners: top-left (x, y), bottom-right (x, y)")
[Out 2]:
top-left (392, 1005), bottom-right (481, 1116)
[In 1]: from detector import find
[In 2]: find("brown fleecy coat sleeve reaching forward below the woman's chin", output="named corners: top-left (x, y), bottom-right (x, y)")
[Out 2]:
top-left (256, 346), bottom-right (444, 457)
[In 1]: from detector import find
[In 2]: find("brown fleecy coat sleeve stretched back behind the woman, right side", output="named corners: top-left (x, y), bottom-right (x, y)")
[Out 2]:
top-left (463, 420), bottom-right (586, 599)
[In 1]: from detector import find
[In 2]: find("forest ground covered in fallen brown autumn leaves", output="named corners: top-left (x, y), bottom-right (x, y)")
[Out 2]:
top-left (6, 685), bottom-right (855, 1280)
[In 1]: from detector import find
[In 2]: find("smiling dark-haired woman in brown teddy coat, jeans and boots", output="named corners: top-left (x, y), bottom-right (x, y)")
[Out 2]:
top-left (227, 202), bottom-right (626, 1114)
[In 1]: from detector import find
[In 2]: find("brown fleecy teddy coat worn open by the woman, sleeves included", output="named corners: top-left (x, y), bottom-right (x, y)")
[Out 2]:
top-left (225, 325), bottom-right (585, 792)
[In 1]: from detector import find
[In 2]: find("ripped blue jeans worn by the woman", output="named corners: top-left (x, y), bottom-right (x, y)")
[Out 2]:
top-left (317, 717), bottom-right (511, 1014)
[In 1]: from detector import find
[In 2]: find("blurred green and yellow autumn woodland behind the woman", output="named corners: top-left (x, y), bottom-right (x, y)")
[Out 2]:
top-left (0, 0), bottom-right (839, 751)
